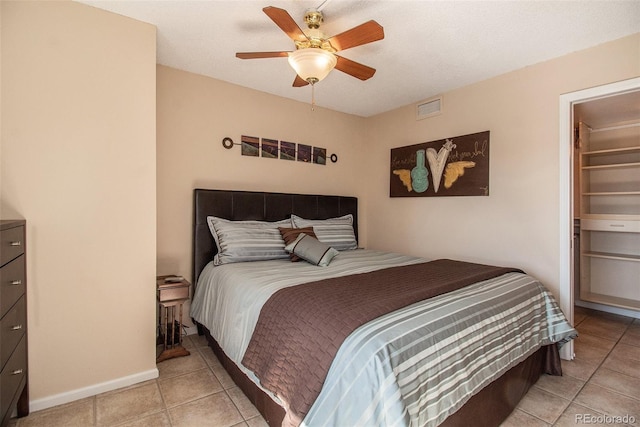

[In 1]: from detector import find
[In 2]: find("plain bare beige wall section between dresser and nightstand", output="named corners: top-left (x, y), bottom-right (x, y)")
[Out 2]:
top-left (1, 1), bottom-right (157, 410)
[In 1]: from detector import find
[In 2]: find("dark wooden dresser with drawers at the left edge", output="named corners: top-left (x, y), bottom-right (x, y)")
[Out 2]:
top-left (0, 220), bottom-right (29, 426)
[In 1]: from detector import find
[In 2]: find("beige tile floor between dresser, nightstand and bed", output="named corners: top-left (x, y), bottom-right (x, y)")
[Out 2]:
top-left (12, 335), bottom-right (267, 427)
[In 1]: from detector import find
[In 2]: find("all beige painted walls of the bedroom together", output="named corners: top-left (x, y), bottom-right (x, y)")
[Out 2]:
top-left (0, 1), bottom-right (640, 412)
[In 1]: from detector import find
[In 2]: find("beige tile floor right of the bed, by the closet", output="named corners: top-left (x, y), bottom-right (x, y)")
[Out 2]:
top-left (502, 307), bottom-right (640, 427)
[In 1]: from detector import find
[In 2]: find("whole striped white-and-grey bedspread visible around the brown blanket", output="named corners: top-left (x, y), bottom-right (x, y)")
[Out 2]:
top-left (191, 249), bottom-right (576, 427)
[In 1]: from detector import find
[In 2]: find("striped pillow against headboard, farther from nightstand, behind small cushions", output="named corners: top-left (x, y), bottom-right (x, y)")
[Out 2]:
top-left (291, 214), bottom-right (358, 251)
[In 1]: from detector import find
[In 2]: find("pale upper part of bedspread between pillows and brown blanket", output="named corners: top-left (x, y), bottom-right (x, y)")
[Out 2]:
top-left (191, 249), bottom-right (425, 366)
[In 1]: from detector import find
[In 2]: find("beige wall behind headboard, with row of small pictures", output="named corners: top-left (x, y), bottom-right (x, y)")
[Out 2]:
top-left (157, 66), bottom-right (369, 284)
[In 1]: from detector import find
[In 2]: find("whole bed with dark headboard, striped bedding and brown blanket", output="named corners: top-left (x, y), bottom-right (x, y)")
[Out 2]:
top-left (191, 189), bottom-right (576, 427)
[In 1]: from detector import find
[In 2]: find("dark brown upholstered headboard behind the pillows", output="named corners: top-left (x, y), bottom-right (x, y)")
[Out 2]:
top-left (192, 189), bottom-right (358, 286)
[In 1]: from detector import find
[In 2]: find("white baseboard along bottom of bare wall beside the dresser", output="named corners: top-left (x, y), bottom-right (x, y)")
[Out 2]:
top-left (29, 368), bottom-right (158, 412)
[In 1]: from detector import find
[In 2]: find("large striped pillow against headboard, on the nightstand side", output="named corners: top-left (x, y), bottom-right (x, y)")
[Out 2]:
top-left (207, 216), bottom-right (291, 265)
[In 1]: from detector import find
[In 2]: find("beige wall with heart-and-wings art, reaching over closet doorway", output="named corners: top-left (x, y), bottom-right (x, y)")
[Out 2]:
top-left (364, 34), bottom-right (640, 295)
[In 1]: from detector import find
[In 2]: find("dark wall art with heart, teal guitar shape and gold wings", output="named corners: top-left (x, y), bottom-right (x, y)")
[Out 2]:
top-left (389, 131), bottom-right (489, 197)
